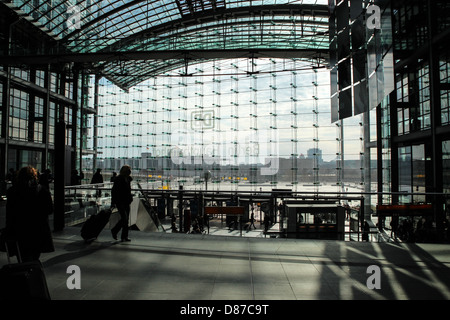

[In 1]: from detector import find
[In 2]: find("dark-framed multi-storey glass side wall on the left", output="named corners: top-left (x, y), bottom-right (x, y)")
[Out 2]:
top-left (0, 62), bottom-right (85, 180)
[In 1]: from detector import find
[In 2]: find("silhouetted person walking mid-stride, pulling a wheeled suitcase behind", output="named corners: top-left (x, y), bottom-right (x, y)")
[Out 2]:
top-left (111, 165), bottom-right (133, 241)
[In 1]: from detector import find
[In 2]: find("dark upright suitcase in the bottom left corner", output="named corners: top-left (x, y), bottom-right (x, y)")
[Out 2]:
top-left (0, 242), bottom-right (51, 300)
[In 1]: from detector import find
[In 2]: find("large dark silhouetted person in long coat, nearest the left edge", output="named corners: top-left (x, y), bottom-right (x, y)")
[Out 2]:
top-left (6, 166), bottom-right (55, 261)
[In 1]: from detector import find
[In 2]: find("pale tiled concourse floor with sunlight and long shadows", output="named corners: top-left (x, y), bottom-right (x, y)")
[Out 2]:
top-left (0, 227), bottom-right (450, 301)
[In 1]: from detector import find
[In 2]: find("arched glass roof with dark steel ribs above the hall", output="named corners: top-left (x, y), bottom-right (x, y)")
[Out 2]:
top-left (6, 0), bottom-right (329, 87)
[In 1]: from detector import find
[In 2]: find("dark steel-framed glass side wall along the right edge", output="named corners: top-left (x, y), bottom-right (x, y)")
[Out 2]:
top-left (378, 0), bottom-right (449, 238)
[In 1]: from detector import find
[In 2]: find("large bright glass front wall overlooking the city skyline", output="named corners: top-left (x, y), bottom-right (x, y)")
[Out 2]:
top-left (84, 59), bottom-right (364, 191)
